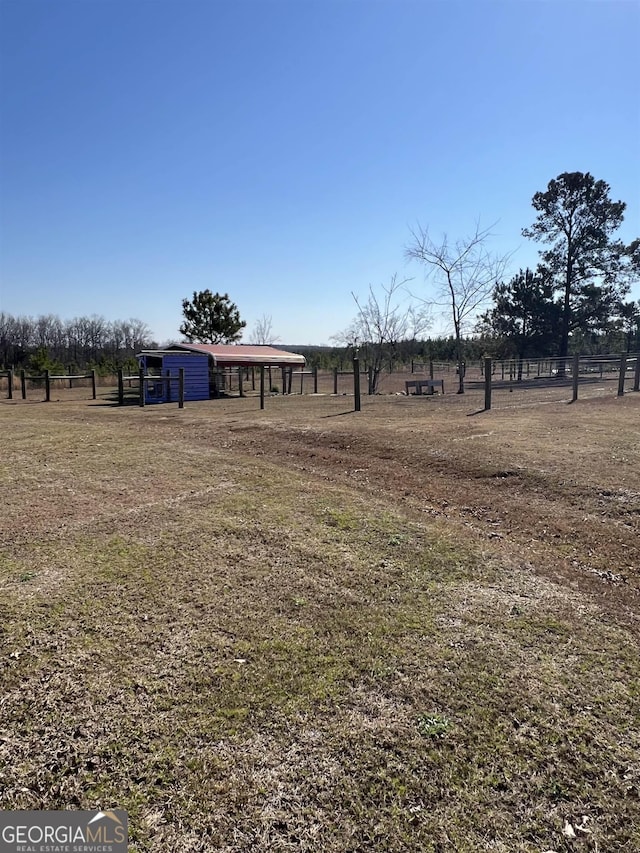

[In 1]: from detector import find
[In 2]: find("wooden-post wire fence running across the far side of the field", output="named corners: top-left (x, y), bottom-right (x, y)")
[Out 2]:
top-left (0, 353), bottom-right (640, 408)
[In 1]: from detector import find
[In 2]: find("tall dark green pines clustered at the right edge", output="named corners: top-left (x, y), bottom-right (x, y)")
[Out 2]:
top-left (478, 172), bottom-right (640, 359)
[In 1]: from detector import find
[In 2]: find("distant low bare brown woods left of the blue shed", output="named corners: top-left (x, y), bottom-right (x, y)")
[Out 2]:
top-left (0, 311), bottom-right (156, 373)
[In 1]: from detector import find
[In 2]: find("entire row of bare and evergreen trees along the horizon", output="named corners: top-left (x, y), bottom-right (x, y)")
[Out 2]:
top-left (0, 172), bottom-right (640, 386)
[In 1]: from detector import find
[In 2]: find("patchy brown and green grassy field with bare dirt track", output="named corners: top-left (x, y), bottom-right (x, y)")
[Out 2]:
top-left (0, 392), bottom-right (640, 853)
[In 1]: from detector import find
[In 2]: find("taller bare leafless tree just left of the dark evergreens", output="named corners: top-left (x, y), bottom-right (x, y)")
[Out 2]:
top-left (406, 223), bottom-right (511, 394)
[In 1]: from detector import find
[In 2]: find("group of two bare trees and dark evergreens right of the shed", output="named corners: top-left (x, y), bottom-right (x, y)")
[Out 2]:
top-left (334, 172), bottom-right (640, 393)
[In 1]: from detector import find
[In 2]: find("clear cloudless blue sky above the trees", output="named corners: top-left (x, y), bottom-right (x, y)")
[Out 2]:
top-left (0, 0), bottom-right (640, 344)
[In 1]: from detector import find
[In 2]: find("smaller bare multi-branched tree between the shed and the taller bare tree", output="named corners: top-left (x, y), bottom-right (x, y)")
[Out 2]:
top-left (332, 275), bottom-right (430, 394)
